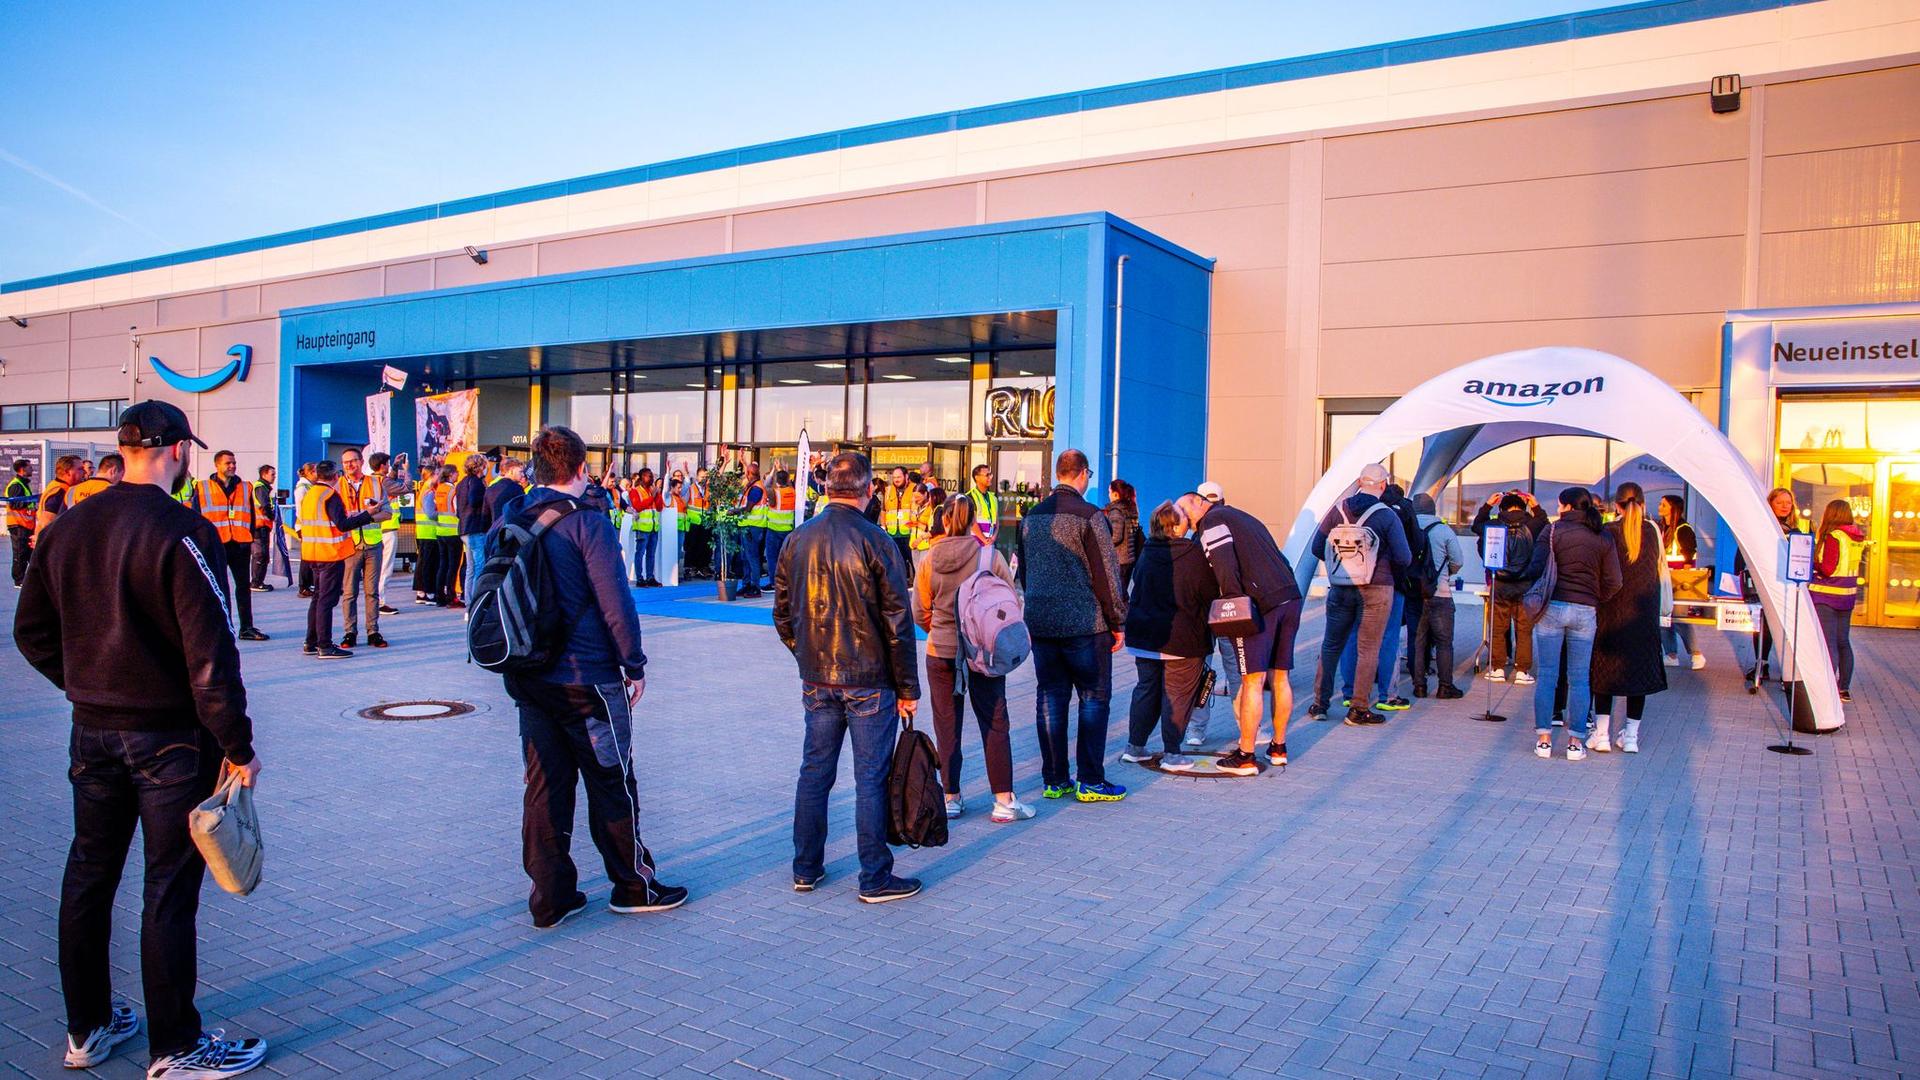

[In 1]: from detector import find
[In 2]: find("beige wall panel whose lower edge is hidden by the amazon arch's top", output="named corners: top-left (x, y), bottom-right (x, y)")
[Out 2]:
top-left (1319, 311), bottom-right (1724, 398)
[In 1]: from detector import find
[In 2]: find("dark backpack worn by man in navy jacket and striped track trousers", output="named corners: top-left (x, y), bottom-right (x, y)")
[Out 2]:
top-left (467, 500), bottom-right (582, 675)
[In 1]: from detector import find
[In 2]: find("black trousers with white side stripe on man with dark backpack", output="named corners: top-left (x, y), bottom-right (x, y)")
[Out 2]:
top-left (507, 675), bottom-right (653, 920)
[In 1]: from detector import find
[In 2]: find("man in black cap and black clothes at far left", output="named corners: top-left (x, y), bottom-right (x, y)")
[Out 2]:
top-left (13, 402), bottom-right (267, 1078)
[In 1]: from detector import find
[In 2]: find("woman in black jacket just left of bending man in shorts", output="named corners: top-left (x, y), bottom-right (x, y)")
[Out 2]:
top-left (1119, 502), bottom-right (1219, 771)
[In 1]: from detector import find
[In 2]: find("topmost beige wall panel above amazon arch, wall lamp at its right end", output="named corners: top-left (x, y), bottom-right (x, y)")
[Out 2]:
top-left (1327, 98), bottom-right (1747, 198)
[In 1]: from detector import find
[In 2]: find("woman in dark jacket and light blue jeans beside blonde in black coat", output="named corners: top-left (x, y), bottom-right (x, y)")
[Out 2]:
top-left (1526, 488), bottom-right (1620, 761)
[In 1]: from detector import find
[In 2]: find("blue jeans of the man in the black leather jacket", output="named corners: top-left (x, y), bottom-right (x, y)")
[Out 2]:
top-left (793, 682), bottom-right (900, 892)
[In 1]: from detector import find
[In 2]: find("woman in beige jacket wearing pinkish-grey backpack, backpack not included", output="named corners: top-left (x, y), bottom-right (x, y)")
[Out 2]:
top-left (914, 500), bottom-right (1033, 824)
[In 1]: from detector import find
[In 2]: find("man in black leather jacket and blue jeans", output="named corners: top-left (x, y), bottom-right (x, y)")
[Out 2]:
top-left (774, 450), bottom-right (920, 903)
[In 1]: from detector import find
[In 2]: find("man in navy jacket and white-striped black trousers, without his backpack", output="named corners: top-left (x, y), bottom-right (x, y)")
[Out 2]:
top-left (495, 427), bottom-right (687, 930)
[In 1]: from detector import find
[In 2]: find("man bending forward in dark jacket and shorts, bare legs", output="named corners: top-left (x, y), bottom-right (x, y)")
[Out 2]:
top-left (1181, 484), bottom-right (1306, 776)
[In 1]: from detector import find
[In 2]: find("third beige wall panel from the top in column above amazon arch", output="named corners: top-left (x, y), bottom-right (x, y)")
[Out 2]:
top-left (1328, 236), bottom-right (1743, 329)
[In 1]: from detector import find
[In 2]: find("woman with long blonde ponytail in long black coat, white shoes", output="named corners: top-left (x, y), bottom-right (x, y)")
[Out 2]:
top-left (1586, 482), bottom-right (1667, 753)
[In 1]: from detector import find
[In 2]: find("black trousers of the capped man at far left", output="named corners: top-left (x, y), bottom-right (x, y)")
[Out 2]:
top-left (60, 724), bottom-right (221, 1057)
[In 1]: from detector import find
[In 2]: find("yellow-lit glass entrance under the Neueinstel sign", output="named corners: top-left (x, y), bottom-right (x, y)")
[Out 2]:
top-left (1780, 452), bottom-right (1920, 626)
